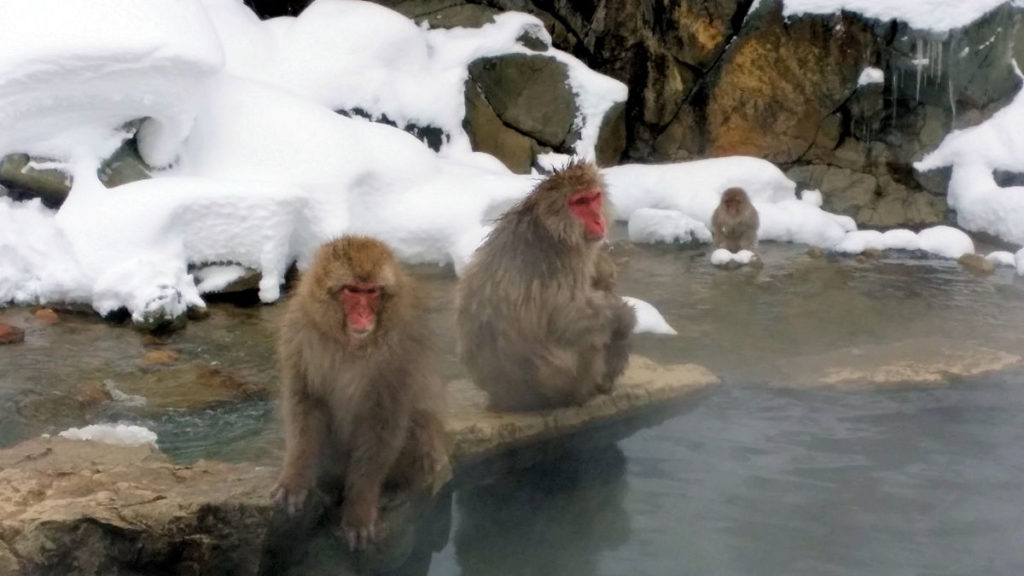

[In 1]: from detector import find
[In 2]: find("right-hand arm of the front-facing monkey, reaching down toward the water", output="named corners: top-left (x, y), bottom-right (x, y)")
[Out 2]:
top-left (341, 370), bottom-right (415, 548)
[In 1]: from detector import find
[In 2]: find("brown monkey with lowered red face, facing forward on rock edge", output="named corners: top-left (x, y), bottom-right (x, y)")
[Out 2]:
top-left (271, 236), bottom-right (447, 548)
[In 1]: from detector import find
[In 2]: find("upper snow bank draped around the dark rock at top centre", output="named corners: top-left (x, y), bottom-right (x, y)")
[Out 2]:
top-left (204, 0), bottom-right (627, 158)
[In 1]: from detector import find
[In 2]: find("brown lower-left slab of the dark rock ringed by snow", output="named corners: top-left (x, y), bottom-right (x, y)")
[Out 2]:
top-left (463, 81), bottom-right (535, 174)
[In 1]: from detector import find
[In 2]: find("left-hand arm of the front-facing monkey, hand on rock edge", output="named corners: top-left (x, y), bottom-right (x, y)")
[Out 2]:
top-left (270, 366), bottom-right (329, 515)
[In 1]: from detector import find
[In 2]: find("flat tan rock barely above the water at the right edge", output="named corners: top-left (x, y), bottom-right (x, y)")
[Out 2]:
top-left (786, 338), bottom-right (1021, 385)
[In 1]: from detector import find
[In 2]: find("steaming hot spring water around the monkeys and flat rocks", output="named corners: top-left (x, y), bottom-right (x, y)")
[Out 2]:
top-left (0, 234), bottom-right (1024, 575)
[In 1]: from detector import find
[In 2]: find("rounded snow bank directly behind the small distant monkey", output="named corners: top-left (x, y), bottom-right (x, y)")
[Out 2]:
top-left (603, 156), bottom-right (846, 247)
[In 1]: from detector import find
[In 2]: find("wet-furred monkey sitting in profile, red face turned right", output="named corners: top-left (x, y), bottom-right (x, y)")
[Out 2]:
top-left (456, 158), bottom-right (636, 410)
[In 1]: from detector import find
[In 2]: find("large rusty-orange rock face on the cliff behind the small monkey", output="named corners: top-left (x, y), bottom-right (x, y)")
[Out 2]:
top-left (708, 2), bottom-right (877, 163)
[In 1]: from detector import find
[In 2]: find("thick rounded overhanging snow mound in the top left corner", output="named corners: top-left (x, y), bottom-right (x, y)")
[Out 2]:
top-left (0, 0), bottom-right (223, 165)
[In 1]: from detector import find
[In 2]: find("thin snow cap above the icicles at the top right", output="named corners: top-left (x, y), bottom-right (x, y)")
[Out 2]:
top-left (782, 0), bottom-right (1006, 32)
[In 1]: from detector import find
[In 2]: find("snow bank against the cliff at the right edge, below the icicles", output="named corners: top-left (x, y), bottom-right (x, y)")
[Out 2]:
top-left (914, 91), bottom-right (1024, 244)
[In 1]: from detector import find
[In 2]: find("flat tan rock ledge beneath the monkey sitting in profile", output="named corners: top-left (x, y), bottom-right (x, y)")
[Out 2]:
top-left (447, 356), bottom-right (719, 461)
